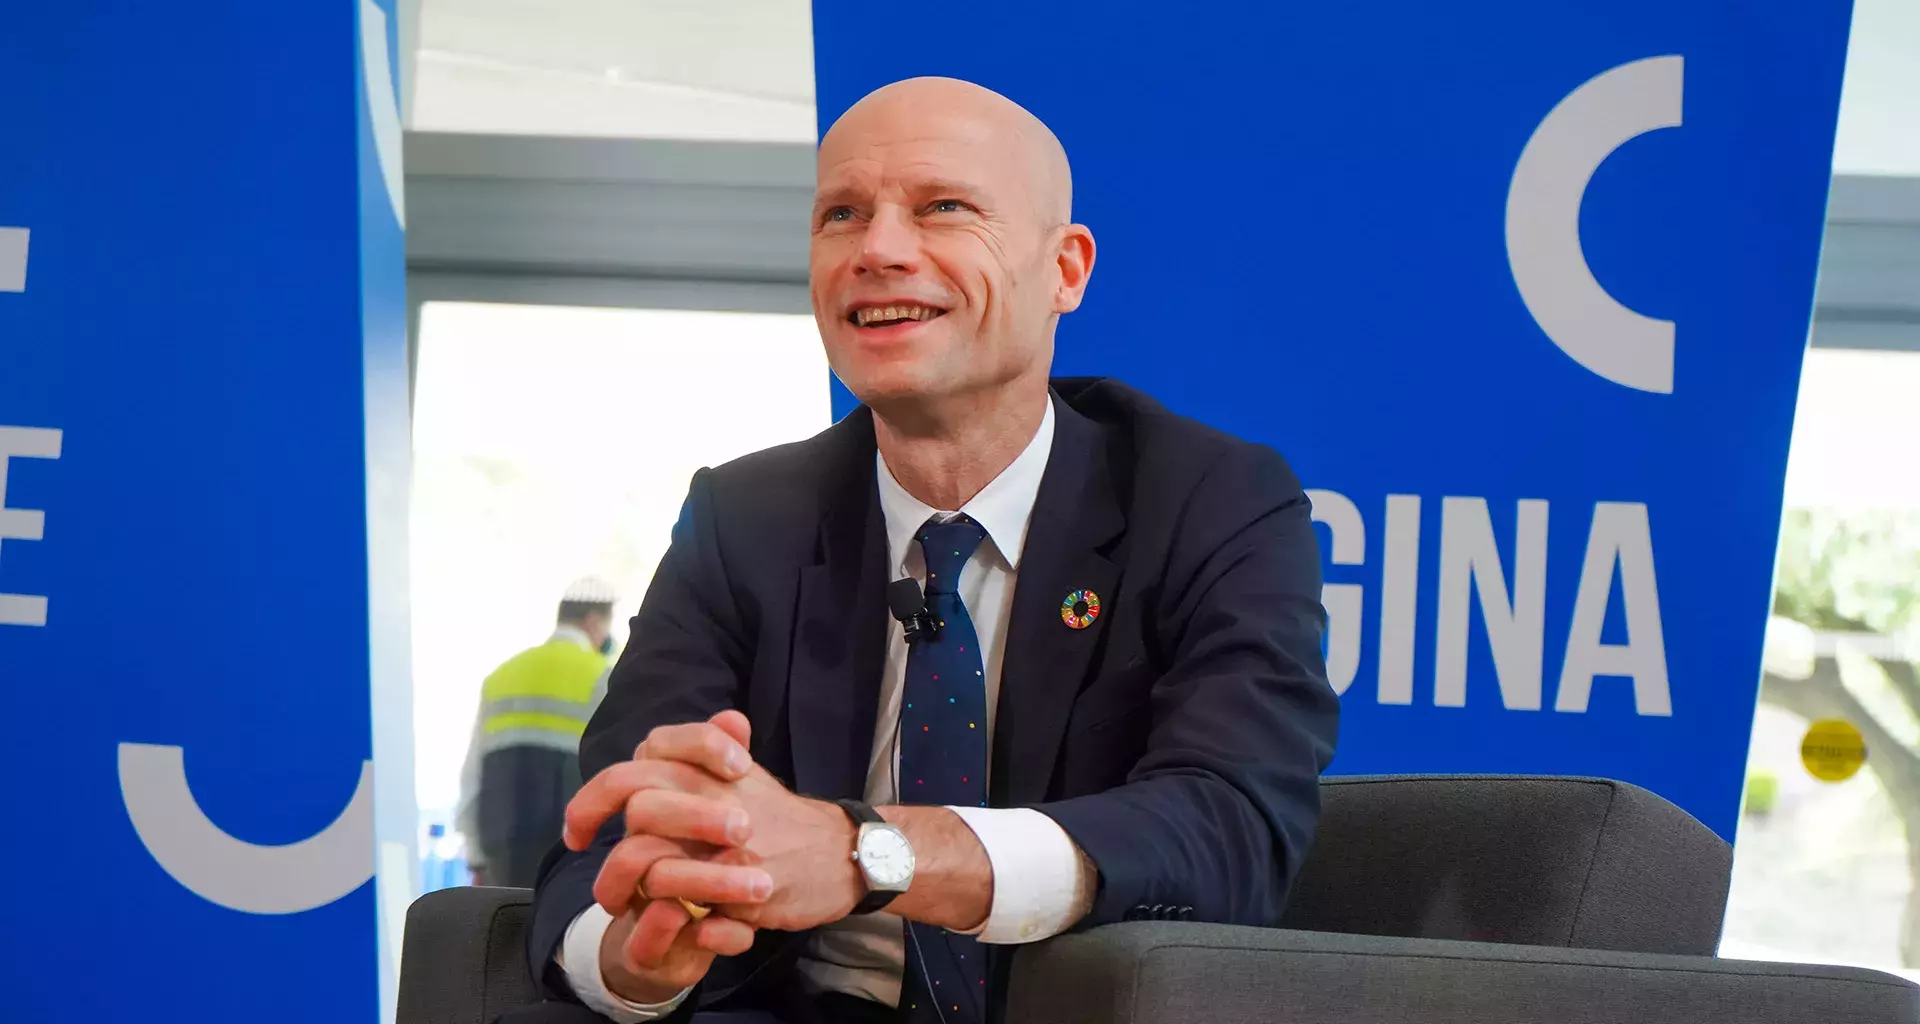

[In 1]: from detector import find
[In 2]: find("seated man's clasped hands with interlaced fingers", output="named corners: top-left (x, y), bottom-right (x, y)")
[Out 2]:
top-left (564, 711), bottom-right (864, 1003)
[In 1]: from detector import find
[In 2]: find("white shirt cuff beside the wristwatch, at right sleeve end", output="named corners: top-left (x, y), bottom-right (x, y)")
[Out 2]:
top-left (948, 807), bottom-right (1100, 945)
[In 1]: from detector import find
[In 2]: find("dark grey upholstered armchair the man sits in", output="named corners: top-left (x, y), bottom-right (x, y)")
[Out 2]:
top-left (399, 776), bottom-right (1920, 1024)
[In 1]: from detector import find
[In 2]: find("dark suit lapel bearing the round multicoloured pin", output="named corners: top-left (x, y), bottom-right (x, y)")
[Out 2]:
top-left (991, 400), bottom-right (1125, 807)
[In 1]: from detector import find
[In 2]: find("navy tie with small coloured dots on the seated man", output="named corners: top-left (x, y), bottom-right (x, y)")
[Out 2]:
top-left (900, 517), bottom-right (987, 1024)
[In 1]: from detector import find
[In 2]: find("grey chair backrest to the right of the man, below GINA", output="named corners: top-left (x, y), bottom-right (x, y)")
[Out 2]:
top-left (1281, 776), bottom-right (1734, 957)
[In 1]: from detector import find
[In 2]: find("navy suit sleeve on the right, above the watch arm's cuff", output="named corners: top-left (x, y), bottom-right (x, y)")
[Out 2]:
top-left (1039, 446), bottom-right (1338, 928)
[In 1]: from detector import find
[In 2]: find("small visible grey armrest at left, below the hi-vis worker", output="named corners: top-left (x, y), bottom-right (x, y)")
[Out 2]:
top-left (397, 886), bottom-right (540, 1024)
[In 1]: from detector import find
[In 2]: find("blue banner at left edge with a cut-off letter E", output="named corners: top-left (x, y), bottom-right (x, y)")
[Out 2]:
top-left (0, 0), bottom-right (413, 1022)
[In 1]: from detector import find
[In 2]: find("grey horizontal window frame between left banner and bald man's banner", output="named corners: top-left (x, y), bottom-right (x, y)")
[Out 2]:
top-left (405, 133), bottom-right (814, 399)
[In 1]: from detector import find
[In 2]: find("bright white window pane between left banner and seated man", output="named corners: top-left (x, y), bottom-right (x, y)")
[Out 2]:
top-left (411, 304), bottom-right (829, 820)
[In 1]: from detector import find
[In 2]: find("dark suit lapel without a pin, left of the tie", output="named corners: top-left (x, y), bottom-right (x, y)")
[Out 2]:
top-left (787, 409), bottom-right (891, 797)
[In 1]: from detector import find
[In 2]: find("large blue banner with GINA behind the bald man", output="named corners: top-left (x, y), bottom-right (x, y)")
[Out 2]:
top-left (814, 0), bottom-right (1851, 840)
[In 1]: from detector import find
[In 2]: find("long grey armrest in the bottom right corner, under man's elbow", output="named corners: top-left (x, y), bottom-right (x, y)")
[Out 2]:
top-left (1006, 922), bottom-right (1920, 1024)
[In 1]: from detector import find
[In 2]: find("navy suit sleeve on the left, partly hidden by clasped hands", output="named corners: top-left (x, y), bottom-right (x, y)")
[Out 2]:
top-left (526, 469), bottom-right (764, 999)
